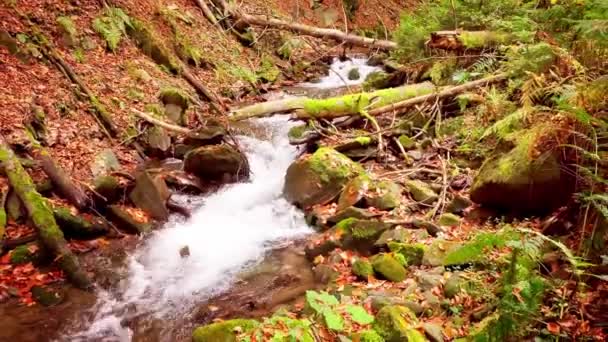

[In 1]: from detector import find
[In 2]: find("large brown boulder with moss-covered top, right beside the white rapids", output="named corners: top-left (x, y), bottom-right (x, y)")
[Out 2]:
top-left (283, 147), bottom-right (364, 208)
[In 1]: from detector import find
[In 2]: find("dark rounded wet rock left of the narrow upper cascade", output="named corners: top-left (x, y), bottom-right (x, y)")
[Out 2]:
top-left (184, 144), bottom-right (249, 181)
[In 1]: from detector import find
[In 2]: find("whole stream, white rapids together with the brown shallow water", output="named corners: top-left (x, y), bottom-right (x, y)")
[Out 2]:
top-left (5, 58), bottom-right (377, 342)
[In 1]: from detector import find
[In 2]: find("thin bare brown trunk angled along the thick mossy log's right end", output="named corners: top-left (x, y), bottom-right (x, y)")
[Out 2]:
top-left (369, 74), bottom-right (507, 116)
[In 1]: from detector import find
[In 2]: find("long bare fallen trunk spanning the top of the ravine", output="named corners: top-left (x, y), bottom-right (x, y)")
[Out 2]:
top-left (220, 0), bottom-right (397, 50)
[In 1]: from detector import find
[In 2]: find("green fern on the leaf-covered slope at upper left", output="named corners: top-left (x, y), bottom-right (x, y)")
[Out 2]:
top-left (93, 8), bottom-right (133, 52)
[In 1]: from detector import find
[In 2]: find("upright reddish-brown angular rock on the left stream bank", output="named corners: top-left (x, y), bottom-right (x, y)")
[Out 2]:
top-left (129, 171), bottom-right (171, 221)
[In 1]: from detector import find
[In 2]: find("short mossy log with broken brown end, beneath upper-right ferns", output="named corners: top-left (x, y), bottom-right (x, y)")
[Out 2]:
top-left (427, 31), bottom-right (513, 50)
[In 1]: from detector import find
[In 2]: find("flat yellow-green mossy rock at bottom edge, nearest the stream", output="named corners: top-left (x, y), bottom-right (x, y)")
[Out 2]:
top-left (192, 319), bottom-right (259, 342)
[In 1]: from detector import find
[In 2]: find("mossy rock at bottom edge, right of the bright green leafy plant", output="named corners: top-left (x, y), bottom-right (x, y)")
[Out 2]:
top-left (374, 305), bottom-right (425, 342)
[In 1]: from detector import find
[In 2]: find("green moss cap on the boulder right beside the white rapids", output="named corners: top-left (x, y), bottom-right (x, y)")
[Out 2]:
top-left (309, 147), bottom-right (365, 183)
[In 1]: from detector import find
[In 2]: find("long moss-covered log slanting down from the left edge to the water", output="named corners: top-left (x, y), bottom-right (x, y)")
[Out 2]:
top-left (0, 136), bottom-right (91, 289)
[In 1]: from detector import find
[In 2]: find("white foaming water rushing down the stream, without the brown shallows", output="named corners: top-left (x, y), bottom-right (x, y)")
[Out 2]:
top-left (61, 58), bottom-right (377, 341)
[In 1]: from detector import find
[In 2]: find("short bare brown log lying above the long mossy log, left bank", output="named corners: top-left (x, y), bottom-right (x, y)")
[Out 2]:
top-left (30, 136), bottom-right (90, 209)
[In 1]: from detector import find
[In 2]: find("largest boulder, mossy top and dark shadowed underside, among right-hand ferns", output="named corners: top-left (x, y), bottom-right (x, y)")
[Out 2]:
top-left (470, 123), bottom-right (574, 212)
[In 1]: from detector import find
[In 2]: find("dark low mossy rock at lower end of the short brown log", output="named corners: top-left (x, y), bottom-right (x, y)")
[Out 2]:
top-left (53, 208), bottom-right (110, 239)
